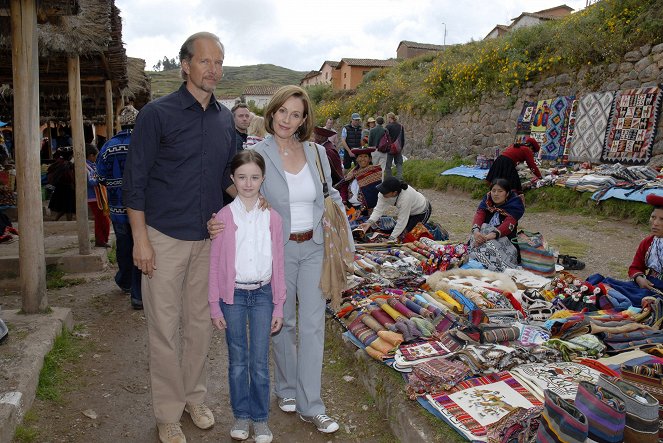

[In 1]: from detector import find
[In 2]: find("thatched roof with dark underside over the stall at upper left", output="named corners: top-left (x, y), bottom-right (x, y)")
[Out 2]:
top-left (0, 0), bottom-right (149, 122)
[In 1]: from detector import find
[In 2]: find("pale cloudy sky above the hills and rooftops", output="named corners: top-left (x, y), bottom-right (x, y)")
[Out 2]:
top-left (115, 0), bottom-right (585, 71)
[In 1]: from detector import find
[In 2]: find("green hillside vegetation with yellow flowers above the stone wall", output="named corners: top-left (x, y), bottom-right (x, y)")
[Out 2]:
top-left (310, 0), bottom-right (663, 123)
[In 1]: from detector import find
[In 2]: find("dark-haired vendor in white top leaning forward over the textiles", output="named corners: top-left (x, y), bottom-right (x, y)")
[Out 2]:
top-left (360, 177), bottom-right (433, 241)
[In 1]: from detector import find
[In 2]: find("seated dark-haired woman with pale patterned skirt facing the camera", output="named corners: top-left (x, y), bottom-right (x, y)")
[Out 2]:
top-left (470, 178), bottom-right (525, 272)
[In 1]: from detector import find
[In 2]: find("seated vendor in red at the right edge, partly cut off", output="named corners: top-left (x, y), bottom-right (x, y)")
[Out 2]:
top-left (587, 194), bottom-right (663, 306)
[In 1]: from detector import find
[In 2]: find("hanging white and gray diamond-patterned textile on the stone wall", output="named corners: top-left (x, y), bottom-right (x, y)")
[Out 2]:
top-left (566, 92), bottom-right (615, 162)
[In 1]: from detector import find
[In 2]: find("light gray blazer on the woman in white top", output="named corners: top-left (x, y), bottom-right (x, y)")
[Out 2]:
top-left (253, 137), bottom-right (354, 246)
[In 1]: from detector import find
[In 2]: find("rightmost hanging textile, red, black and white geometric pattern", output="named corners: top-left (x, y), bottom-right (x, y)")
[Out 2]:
top-left (601, 86), bottom-right (661, 164)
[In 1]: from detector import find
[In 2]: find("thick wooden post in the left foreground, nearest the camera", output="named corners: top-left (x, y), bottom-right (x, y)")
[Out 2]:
top-left (10, 0), bottom-right (48, 314)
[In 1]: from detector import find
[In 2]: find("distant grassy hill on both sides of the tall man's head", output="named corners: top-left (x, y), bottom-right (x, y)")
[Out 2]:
top-left (147, 64), bottom-right (306, 98)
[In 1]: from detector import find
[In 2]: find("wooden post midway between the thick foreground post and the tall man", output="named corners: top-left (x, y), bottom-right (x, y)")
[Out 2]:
top-left (67, 55), bottom-right (91, 255)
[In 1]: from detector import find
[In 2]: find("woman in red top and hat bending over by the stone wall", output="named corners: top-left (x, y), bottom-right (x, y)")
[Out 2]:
top-left (486, 137), bottom-right (541, 194)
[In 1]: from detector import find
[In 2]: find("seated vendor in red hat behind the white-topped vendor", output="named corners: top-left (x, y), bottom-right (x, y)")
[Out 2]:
top-left (335, 148), bottom-right (382, 217)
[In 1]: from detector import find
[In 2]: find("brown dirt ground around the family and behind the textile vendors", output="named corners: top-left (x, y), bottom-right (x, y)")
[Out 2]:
top-left (0, 191), bottom-right (647, 443)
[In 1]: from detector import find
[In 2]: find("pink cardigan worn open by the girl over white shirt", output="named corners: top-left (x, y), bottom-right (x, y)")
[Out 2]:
top-left (207, 206), bottom-right (286, 318)
